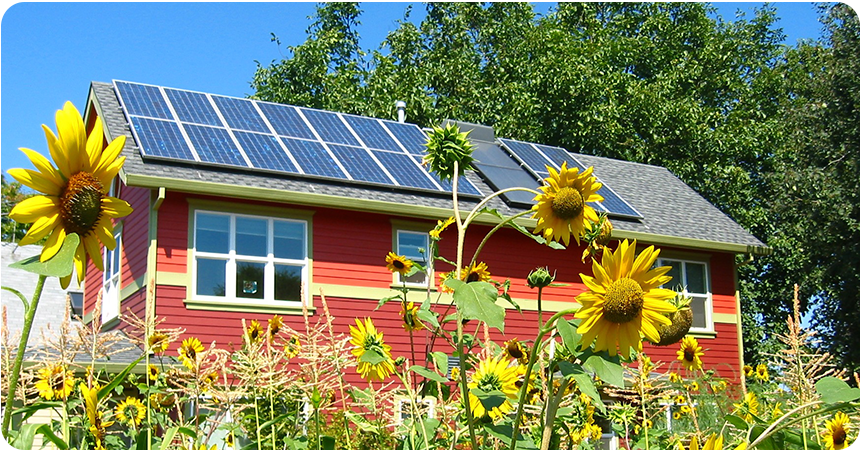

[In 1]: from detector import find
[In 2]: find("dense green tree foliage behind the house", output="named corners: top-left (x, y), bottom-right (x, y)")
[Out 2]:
top-left (251, 3), bottom-right (860, 366)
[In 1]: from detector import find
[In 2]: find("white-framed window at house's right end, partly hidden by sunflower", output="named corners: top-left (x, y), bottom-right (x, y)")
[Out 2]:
top-left (657, 258), bottom-right (714, 331)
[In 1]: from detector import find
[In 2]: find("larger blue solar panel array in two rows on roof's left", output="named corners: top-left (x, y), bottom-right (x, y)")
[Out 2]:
top-left (114, 81), bottom-right (482, 196)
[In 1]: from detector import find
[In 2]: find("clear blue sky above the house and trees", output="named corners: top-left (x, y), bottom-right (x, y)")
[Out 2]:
top-left (0, 2), bottom-right (821, 176)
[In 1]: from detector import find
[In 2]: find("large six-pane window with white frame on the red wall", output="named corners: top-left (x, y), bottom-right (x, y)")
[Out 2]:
top-left (193, 211), bottom-right (308, 302)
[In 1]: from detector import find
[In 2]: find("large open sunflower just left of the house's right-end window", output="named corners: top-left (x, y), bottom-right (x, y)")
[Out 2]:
top-left (576, 239), bottom-right (676, 358)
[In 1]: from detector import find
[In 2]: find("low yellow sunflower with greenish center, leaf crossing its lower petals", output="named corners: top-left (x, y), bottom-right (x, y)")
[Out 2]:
top-left (469, 353), bottom-right (519, 420)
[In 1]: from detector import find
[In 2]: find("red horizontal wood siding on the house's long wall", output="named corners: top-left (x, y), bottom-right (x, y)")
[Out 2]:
top-left (146, 192), bottom-right (740, 385)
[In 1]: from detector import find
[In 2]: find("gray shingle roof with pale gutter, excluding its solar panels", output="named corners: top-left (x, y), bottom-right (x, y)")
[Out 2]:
top-left (89, 82), bottom-right (770, 254)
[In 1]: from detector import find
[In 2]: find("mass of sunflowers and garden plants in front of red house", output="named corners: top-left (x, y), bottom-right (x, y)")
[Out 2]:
top-left (2, 103), bottom-right (860, 450)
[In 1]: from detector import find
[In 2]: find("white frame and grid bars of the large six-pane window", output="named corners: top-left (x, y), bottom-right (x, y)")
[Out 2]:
top-left (190, 209), bottom-right (310, 307)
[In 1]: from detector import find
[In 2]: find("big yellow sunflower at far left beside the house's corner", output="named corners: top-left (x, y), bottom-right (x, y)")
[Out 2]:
top-left (9, 102), bottom-right (132, 289)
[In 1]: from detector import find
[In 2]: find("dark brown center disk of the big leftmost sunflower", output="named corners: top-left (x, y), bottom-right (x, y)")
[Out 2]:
top-left (60, 172), bottom-right (104, 237)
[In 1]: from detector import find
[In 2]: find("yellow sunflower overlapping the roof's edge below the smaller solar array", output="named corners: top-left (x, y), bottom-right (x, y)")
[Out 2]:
top-left (532, 162), bottom-right (603, 245)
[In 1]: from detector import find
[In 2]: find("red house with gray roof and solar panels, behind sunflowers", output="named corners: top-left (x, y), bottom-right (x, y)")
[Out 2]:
top-left (79, 81), bottom-right (769, 381)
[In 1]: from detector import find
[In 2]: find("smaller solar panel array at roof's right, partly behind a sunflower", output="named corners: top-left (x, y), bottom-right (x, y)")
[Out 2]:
top-left (499, 139), bottom-right (642, 219)
